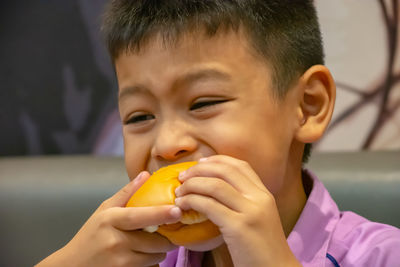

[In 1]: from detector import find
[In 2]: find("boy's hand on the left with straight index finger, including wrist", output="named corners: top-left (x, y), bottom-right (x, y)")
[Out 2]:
top-left (37, 172), bottom-right (182, 266)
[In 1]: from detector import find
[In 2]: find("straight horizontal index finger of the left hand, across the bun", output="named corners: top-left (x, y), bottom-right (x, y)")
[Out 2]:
top-left (104, 205), bottom-right (182, 231)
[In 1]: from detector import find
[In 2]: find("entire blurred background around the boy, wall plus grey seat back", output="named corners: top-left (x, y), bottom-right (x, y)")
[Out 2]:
top-left (0, 0), bottom-right (400, 266)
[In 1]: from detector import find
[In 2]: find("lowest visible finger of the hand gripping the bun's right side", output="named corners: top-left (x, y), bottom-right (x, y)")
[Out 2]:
top-left (175, 194), bottom-right (239, 228)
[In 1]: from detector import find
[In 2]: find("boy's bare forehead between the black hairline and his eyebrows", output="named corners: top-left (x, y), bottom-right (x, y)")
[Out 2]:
top-left (115, 28), bottom-right (271, 96)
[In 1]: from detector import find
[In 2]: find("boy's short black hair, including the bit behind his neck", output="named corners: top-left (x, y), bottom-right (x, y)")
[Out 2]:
top-left (102, 0), bottom-right (324, 162)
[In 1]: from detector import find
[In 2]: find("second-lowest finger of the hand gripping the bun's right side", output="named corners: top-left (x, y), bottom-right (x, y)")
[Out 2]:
top-left (175, 177), bottom-right (247, 212)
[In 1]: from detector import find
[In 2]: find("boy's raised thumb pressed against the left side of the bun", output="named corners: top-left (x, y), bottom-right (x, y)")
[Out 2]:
top-left (101, 171), bottom-right (150, 211)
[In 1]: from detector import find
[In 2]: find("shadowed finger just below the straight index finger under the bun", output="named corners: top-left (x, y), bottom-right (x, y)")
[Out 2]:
top-left (125, 230), bottom-right (177, 253)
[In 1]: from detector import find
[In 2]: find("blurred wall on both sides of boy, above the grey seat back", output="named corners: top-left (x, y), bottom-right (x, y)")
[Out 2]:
top-left (0, 0), bottom-right (400, 156)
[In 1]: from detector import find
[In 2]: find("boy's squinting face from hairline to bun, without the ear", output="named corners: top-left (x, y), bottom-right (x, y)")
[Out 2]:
top-left (115, 32), bottom-right (298, 194)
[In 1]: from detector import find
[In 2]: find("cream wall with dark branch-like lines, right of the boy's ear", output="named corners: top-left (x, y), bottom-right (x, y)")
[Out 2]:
top-left (317, 0), bottom-right (400, 150)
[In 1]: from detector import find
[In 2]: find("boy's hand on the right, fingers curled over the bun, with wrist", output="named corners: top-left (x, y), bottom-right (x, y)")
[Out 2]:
top-left (176, 155), bottom-right (300, 266)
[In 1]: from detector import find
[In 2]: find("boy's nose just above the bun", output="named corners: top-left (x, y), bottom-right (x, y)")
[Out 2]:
top-left (151, 120), bottom-right (198, 162)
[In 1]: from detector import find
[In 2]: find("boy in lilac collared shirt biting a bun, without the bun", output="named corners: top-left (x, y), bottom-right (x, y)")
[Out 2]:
top-left (37, 0), bottom-right (400, 266)
